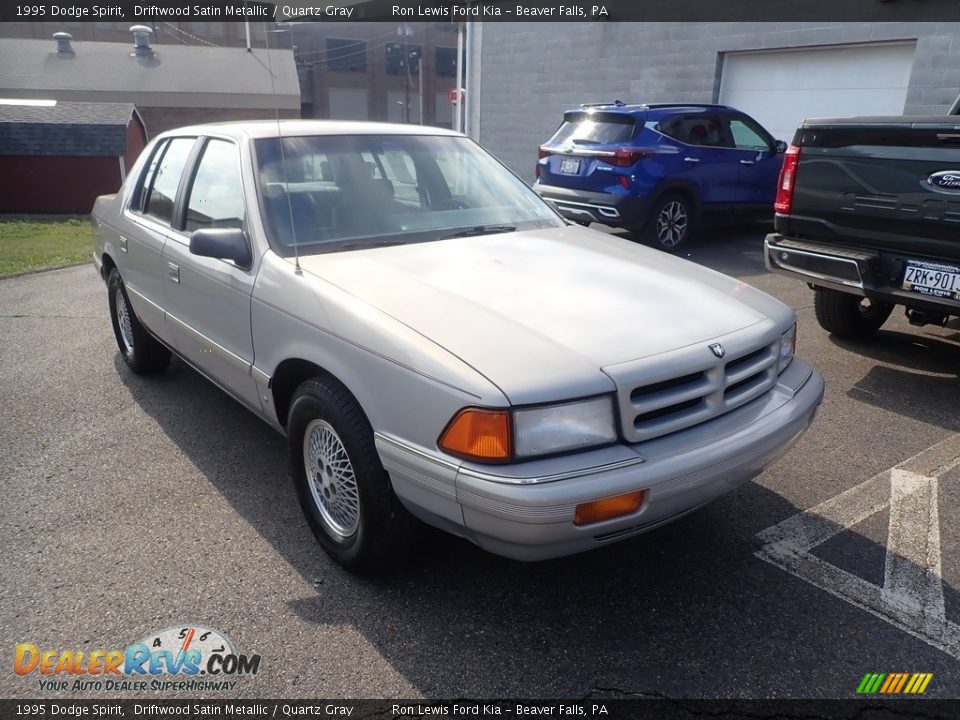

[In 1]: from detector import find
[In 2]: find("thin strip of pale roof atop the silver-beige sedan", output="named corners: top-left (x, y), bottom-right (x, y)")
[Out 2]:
top-left (151, 120), bottom-right (465, 140)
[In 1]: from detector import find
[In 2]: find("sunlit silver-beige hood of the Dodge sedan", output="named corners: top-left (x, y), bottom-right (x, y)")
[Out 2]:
top-left (300, 227), bottom-right (790, 404)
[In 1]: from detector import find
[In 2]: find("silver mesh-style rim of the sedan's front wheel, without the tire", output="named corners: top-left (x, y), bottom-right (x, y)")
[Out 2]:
top-left (303, 419), bottom-right (360, 540)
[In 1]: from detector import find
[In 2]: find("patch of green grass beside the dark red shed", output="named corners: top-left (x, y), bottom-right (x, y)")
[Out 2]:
top-left (0, 218), bottom-right (93, 278)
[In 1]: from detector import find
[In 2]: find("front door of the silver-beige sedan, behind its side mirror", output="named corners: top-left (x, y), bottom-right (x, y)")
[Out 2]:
top-left (163, 138), bottom-right (261, 412)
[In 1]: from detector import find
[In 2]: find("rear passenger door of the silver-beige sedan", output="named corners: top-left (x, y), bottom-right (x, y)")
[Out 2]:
top-left (118, 137), bottom-right (196, 346)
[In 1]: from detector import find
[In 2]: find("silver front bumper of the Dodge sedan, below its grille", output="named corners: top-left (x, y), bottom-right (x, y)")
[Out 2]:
top-left (378, 359), bottom-right (824, 560)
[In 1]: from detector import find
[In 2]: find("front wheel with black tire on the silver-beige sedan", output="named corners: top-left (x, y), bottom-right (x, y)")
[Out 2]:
top-left (287, 378), bottom-right (418, 574)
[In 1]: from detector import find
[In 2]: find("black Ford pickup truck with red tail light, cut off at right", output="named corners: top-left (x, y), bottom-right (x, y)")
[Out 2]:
top-left (764, 116), bottom-right (960, 338)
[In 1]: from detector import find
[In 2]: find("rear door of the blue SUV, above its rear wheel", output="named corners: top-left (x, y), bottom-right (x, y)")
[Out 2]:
top-left (658, 112), bottom-right (737, 210)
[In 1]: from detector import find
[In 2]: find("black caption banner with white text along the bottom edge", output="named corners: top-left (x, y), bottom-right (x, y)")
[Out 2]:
top-left (0, 698), bottom-right (960, 720)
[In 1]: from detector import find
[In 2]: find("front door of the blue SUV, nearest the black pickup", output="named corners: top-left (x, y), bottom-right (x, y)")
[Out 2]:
top-left (728, 115), bottom-right (783, 207)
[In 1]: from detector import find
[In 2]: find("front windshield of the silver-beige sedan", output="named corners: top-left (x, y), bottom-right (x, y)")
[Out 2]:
top-left (256, 135), bottom-right (563, 256)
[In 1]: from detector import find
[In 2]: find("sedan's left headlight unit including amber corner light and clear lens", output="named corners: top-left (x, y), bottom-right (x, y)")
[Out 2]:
top-left (437, 395), bottom-right (617, 462)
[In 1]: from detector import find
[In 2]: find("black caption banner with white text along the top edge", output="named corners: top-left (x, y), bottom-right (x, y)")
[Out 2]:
top-left (0, 0), bottom-right (960, 23)
